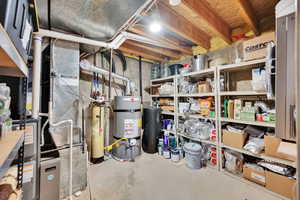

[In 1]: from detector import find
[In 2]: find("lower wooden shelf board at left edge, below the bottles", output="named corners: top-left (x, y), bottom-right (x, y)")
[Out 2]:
top-left (0, 131), bottom-right (24, 179)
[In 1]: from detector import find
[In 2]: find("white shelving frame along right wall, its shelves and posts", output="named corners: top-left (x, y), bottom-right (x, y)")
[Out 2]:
top-left (151, 59), bottom-right (297, 199)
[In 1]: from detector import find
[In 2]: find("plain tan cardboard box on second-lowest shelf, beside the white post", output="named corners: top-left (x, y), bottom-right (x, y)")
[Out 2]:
top-left (222, 130), bottom-right (248, 149)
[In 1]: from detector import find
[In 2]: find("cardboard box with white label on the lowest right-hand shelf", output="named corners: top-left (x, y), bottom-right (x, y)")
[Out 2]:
top-left (243, 165), bottom-right (266, 186)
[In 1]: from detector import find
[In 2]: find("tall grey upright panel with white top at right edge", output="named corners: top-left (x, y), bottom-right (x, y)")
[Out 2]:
top-left (275, 0), bottom-right (296, 141)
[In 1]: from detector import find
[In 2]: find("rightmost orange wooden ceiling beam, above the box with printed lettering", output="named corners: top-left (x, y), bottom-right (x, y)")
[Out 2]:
top-left (231, 0), bottom-right (260, 35)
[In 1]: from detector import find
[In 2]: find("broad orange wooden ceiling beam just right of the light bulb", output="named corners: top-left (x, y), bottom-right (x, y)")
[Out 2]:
top-left (161, 0), bottom-right (232, 44)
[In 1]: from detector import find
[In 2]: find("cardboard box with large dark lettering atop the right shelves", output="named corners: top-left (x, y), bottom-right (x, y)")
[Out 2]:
top-left (243, 32), bottom-right (275, 61)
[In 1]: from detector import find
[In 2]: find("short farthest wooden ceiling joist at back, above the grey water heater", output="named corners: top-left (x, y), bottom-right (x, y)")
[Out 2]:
top-left (119, 43), bottom-right (166, 62)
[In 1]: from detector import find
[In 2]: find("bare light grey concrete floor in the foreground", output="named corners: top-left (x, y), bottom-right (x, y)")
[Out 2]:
top-left (76, 153), bottom-right (279, 200)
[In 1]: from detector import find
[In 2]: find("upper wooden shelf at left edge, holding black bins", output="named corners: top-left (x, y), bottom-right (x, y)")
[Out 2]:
top-left (0, 24), bottom-right (28, 77)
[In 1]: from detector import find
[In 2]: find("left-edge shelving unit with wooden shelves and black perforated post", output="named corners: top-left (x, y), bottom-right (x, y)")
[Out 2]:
top-left (0, 24), bottom-right (28, 188)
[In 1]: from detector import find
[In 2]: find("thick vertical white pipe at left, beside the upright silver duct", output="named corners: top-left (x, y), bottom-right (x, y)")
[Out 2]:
top-left (32, 36), bottom-right (42, 119)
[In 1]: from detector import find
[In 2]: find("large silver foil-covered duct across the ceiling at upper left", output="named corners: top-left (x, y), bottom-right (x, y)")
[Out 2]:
top-left (37, 0), bottom-right (154, 41)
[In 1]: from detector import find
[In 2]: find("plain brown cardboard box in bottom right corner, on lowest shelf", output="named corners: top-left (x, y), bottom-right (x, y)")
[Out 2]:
top-left (266, 171), bottom-right (296, 199)
